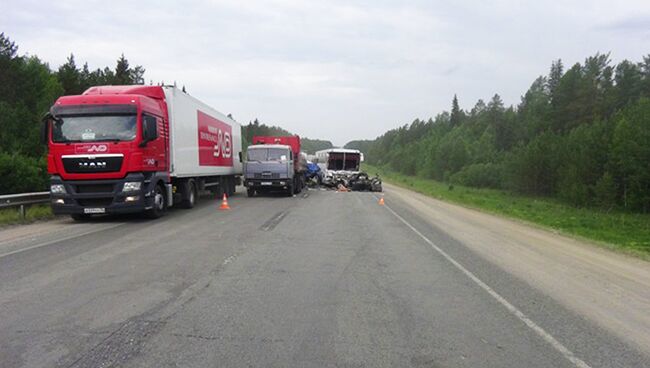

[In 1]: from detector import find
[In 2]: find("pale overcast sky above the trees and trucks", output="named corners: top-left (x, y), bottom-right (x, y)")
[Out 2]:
top-left (0, 0), bottom-right (650, 145)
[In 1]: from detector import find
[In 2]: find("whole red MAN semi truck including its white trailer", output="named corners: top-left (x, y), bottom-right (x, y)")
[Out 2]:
top-left (41, 85), bottom-right (242, 221)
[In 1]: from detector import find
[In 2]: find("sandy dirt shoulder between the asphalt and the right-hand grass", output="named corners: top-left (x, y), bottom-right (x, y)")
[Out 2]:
top-left (385, 184), bottom-right (650, 356)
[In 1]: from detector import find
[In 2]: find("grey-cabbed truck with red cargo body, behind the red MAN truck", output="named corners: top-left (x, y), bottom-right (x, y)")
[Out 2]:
top-left (244, 135), bottom-right (307, 197)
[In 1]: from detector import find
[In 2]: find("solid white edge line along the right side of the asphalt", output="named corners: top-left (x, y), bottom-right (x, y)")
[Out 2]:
top-left (384, 198), bottom-right (591, 368)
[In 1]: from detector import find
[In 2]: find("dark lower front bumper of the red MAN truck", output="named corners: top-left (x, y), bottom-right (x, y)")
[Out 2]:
top-left (50, 173), bottom-right (154, 215)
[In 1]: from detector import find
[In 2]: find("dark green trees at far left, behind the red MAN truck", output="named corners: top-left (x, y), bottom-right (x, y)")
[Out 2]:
top-left (0, 33), bottom-right (145, 194)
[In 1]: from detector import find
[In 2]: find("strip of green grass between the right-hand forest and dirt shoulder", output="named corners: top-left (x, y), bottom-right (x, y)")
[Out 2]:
top-left (363, 165), bottom-right (650, 260)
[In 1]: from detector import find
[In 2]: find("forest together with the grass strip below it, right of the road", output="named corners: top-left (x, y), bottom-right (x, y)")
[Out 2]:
top-left (346, 54), bottom-right (650, 255)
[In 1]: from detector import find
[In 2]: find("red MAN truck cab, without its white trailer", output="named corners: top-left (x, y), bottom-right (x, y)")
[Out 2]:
top-left (44, 86), bottom-right (171, 219)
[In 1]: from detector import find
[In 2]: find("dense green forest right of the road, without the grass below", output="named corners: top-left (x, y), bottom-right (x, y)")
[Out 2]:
top-left (360, 54), bottom-right (650, 213)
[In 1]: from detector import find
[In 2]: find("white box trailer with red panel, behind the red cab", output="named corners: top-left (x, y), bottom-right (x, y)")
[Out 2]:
top-left (163, 87), bottom-right (243, 178)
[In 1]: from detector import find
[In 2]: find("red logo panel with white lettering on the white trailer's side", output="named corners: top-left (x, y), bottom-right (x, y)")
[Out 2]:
top-left (198, 111), bottom-right (232, 166)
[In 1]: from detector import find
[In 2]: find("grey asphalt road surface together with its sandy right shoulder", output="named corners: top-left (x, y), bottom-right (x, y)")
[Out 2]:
top-left (0, 186), bottom-right (650, 368)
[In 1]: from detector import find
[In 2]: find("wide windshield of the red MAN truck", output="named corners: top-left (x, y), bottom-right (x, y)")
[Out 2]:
top-left (52, 115), bottom-right (137, 143)
